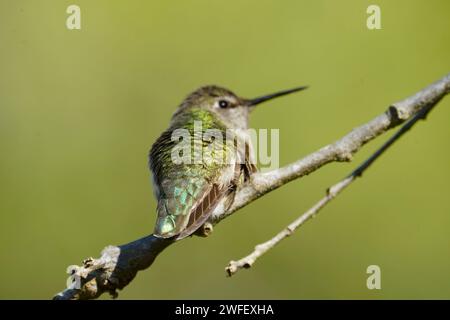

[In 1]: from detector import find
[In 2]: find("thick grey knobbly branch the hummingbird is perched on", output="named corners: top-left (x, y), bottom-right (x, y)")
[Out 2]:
top-left (54, 74), bottom-right (450, 299)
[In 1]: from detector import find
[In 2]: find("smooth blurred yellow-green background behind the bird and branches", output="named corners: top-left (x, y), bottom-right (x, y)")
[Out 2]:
top-left (0, 0), bottom-right (450, 299)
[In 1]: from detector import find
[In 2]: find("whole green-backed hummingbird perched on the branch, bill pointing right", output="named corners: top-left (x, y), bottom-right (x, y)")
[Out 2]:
top-left (149, 85), bottom-right (307, 240)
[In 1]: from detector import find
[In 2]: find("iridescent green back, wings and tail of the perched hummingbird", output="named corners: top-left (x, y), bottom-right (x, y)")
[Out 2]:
top-left (150, 108), bottom-right (235, 238)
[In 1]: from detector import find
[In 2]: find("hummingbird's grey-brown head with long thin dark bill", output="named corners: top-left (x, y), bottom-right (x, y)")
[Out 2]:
top-left (174, 85), bottom-right (307, 129)
